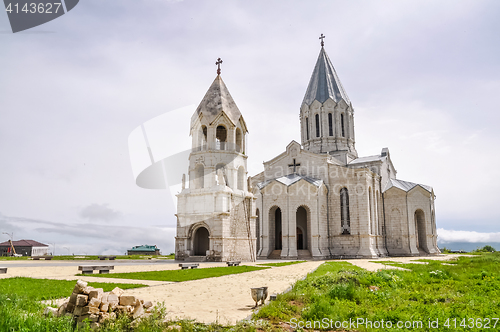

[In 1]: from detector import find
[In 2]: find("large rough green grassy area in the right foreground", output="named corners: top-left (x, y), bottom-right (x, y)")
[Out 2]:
top-left (256, 253), bottom-right (500, 331)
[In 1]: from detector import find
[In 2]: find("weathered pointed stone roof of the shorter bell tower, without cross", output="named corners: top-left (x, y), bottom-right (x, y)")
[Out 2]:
top-left (191, 75), bottom-right (246, 131)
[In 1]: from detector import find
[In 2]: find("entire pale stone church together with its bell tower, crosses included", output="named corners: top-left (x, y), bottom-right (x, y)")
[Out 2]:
top-left (175, 35), bottom-right (440, 261)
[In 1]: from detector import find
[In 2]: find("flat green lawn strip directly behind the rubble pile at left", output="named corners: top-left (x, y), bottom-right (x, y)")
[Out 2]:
top-left (0, 277), bottom-right (145, 301)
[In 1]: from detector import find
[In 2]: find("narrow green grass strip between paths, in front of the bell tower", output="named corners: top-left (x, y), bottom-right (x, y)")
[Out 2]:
top-left (81, 266), bottom-right (268, 282)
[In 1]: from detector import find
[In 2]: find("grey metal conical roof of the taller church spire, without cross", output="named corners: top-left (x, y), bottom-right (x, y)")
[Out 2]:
top-left (303, 47), bottom-right (350, 105)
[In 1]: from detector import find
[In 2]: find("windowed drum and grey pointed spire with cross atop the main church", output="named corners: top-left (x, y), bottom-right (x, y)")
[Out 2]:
top-left (300, 34), bottom-right (358, 163)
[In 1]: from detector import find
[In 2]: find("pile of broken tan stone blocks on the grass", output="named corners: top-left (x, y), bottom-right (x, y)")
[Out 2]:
top-left (45, 280), bottom-right (153, 326)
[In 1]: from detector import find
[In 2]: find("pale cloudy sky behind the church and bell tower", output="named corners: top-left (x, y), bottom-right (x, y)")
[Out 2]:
top-left (0, 0), bottom-right (500, 254)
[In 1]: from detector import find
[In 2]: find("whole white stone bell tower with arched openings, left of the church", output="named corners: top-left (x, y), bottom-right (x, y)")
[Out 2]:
top-left (175, 58), bottom-right (256, 261)
